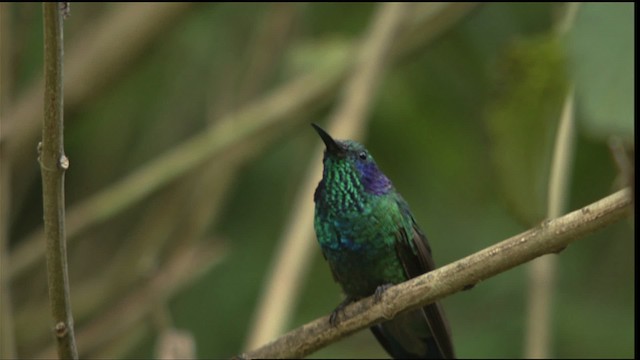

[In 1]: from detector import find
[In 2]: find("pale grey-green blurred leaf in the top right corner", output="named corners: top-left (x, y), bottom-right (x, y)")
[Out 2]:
top-left (567, 3), bottom-right (635, 140)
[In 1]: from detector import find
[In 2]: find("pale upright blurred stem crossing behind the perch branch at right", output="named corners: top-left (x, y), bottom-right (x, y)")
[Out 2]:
top-left (524, 86), bottom-right (575, 358)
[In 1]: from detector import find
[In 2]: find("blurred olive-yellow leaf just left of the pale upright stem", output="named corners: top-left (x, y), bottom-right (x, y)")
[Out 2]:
top-left (486, 35), bottom-right (568, 225)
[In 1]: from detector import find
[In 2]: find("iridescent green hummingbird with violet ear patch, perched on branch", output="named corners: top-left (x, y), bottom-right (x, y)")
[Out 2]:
top-left (311, 124), bottom-right (455, 359)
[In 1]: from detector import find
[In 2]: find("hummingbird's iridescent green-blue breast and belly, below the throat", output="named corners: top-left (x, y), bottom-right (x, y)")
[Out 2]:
top-left (315, 193), bottom-right (411, 297)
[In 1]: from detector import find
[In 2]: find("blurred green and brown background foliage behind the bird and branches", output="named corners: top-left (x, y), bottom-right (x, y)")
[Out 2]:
top-left (0, 3), bottom-right (635, 358)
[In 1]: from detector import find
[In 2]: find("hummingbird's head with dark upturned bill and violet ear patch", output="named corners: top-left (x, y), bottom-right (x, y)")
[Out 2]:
top-left (311, 124), bottom-right (393, 195)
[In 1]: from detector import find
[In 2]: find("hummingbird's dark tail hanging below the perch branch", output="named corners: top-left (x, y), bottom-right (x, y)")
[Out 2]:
top-left (371, 303), bottom-right (455, 359)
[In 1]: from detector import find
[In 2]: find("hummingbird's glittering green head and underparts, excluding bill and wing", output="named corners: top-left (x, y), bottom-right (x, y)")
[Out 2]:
top-left (314, 136), bottom-right (412, 297)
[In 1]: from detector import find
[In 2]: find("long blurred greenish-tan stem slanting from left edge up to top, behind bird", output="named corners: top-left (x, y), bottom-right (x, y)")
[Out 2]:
top-left (8, 3), bottom-right (477, 279)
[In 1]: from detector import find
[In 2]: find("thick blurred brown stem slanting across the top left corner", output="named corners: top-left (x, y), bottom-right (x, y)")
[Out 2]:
top-left (0, 2), bottom-right (193, 210)
